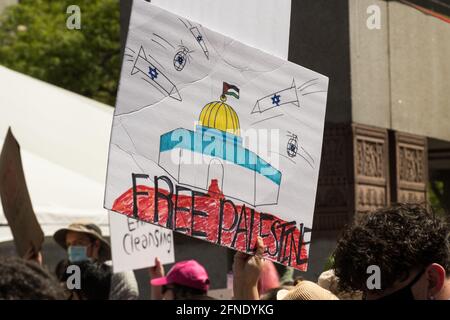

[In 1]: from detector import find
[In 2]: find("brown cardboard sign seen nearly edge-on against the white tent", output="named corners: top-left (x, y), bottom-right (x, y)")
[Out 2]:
top-left (0, 129), bottom-right (44, 257)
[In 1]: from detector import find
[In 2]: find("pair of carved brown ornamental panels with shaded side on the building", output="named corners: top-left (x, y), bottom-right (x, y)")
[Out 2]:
top-left (313, 124), bottom-right (428, 231)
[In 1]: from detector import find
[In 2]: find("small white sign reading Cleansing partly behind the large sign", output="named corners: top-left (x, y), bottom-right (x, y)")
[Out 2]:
top-left (109, 211), bottom-right (175, 273)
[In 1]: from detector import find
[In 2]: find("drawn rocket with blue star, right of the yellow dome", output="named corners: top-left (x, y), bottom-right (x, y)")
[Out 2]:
top-left (251, 79), bottom-right (300, 114)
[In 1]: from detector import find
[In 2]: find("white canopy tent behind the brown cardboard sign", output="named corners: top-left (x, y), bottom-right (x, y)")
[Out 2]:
top-left (0, 67), bottom-right (114, 242)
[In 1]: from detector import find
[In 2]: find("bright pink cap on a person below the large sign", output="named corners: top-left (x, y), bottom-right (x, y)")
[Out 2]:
top-left (150, 260), bottom-right (209, 291)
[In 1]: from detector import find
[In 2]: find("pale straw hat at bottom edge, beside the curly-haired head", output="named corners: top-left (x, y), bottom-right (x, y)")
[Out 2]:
top-left (277, 280), bottom-right (339, 300)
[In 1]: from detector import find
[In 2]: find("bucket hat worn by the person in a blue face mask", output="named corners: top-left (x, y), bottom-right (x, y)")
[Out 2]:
top-left (53, 221), bottom-right (111, 262)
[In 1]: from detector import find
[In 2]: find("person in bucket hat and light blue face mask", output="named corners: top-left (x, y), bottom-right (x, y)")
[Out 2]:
top-left (53, 221), bottom-right (139, 300)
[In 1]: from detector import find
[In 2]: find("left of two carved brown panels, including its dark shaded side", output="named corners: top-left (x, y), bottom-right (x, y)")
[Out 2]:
top-left (314, 124), bottom-right (390, 230)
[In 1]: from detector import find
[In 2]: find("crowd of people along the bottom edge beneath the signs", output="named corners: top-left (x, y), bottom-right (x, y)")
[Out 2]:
top-left (0, 204), bottom-right (450, 300)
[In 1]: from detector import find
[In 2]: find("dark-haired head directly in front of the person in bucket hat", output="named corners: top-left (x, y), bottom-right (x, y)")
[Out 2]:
top-left (62, 261), bottom-right (112, 300)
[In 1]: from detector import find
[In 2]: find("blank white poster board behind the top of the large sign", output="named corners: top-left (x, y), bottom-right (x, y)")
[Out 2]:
top-left (151, 0), bottom-right (292, 60)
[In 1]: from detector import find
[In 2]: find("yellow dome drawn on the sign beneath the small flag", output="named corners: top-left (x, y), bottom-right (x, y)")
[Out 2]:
top-left (199, 99), bottom-right (240, 136)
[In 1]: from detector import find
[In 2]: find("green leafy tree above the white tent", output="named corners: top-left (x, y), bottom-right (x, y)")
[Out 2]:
top-left (0, 0), bottom-right (120, 105)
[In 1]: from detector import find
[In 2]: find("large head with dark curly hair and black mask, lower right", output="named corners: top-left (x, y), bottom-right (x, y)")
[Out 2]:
top-left (334, 204), bottom-right (450, 300)
